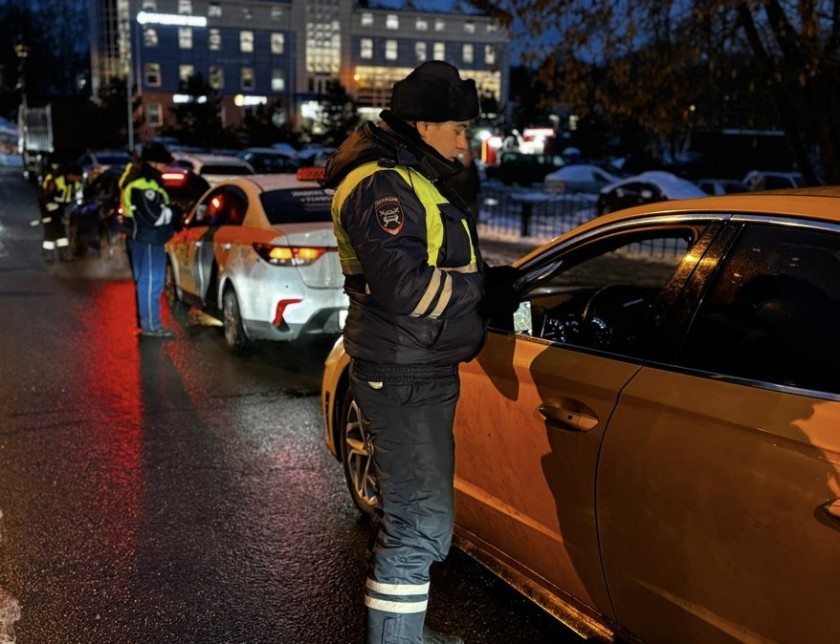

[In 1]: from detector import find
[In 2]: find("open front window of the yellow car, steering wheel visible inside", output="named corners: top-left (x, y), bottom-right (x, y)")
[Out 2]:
top-left (514, 223), bottom-right (708, 356)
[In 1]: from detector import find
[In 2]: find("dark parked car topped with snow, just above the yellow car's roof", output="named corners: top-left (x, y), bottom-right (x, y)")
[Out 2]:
top-left (598, 170), bottom-right (706, 215)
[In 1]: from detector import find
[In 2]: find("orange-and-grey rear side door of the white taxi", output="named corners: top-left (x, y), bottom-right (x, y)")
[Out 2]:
top-left (193, 185), bottom-right (248, 307)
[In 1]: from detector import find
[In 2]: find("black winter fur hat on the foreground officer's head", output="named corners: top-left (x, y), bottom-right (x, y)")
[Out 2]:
top-left (390, 60), bottom-right (479, 123)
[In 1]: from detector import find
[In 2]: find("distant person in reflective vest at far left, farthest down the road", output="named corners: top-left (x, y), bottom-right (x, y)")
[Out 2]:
top-left (38, 163), bottom-right (82, 262)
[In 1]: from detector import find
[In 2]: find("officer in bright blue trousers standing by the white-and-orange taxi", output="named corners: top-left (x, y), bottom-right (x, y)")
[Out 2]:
top-left (122, 143), bottom-right (174, 338)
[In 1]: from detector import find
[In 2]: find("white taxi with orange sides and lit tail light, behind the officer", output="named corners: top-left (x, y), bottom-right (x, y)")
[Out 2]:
top-left (165, 174), bottom-right (347, 352)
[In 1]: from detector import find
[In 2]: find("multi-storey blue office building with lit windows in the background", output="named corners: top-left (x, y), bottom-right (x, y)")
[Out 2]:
top-left (90, 0), bottom-right (510, 140)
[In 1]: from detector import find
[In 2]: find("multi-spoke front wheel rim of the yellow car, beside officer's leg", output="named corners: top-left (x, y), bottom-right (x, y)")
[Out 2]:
top-left (338, 389), bottom-right (379, 515)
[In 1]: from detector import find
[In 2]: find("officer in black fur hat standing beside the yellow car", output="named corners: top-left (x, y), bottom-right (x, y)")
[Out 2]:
top-left (324, 61), bottom-right (492, 644)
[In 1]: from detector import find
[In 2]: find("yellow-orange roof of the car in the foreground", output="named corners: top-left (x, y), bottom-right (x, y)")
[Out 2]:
top-left (532, 186), bottom-right (840, 264)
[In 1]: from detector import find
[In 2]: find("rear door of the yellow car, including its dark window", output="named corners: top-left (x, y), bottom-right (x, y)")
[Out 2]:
top-left (597, 216), bottom-right (840, 642)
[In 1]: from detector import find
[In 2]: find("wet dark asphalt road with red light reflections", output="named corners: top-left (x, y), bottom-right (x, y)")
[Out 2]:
top-left (0, 169), bottom-right (576, 644)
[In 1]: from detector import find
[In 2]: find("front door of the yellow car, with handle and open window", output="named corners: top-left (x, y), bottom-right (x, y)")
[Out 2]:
top-left (456, 219), bottom-right (716, 618)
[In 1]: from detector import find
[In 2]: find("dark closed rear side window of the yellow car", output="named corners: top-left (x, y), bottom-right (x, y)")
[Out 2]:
top-left (679, 225), bottom-right (840, 393)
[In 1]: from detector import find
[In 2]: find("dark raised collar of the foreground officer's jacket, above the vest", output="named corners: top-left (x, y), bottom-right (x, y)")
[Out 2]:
top-left (322, 110), bottom-right (464, 189)
